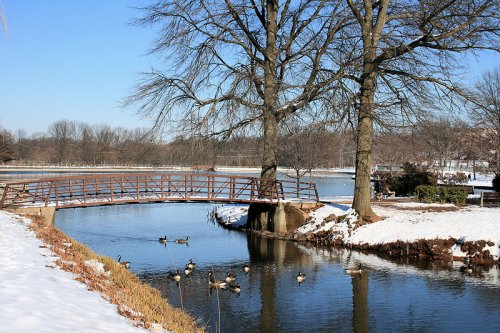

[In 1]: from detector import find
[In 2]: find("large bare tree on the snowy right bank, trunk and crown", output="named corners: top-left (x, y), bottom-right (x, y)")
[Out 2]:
top-left (346, 0), bottom-right (500, 219)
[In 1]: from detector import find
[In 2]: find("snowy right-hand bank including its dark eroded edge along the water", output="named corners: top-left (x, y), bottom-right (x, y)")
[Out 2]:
top-left (217, 203), bottom-right (500, 261)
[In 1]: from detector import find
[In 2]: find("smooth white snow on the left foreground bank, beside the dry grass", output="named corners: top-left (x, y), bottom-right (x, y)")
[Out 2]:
top-left (0, 211), bottom-right (147, 333)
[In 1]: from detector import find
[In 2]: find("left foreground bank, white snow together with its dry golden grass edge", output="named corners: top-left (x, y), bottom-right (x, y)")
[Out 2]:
top-left (0, 210), bottom-right (204, 333)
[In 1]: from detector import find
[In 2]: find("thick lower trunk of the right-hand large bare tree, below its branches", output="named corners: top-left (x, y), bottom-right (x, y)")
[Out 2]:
top-left (352, 73), bottom-right (375, 219)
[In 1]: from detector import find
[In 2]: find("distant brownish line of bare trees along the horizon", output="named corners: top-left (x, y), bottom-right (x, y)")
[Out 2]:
top-left (0, 117), bottom-right (498, 175)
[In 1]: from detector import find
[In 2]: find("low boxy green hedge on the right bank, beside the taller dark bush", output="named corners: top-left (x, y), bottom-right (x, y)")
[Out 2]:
top-left (415, 185), bottom-right (467, 205)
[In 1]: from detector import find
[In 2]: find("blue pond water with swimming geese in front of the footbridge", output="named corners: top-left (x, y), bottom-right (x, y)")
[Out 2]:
top-left (56, 176), bottom-right (500, 332)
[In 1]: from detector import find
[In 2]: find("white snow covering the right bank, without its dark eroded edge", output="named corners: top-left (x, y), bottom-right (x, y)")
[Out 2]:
top-left (217, 203), bottom-right (500, 260)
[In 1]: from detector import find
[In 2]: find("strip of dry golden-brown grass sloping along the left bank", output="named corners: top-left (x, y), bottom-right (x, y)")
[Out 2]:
top-left (25, 216), bottom-right (204, 333)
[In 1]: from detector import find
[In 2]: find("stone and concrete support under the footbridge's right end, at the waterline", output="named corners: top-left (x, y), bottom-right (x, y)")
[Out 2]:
top-left (248, 202), bottom-right (307, 234)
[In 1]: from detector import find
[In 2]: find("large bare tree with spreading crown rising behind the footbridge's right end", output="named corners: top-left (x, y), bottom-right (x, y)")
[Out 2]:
top-left (126, 0), bottom-right (352, 192)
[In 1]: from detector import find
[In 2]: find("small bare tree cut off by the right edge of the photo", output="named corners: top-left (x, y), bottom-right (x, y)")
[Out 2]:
top-left (471, 67), bottom-right (500, 173)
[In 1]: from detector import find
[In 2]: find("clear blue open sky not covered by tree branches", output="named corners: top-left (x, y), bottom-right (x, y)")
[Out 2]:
top-left (0, 0), bottom-right (500, 135)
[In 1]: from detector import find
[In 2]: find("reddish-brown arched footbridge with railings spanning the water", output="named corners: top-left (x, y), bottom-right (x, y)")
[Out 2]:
top-left (0, 173), bottom-right (318, 209)
